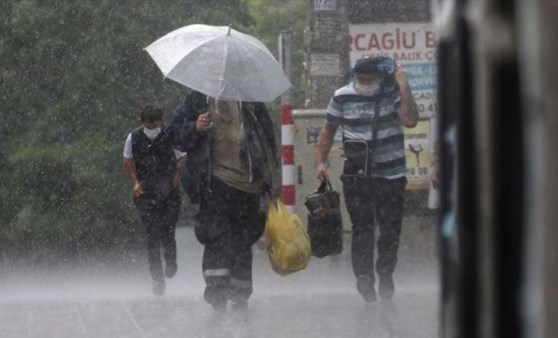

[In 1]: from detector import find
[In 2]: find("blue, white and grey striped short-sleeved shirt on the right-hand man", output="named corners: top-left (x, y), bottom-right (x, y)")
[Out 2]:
top-left (326, 83), bottom-right (407, 179)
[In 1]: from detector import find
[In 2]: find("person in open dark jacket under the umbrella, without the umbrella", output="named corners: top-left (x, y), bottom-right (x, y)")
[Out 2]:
top-left (171, 91), bottom-right (281, 310)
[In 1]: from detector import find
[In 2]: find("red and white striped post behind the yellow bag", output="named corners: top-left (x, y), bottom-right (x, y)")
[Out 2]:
top-left (281, 104), bottom-right (296, 212)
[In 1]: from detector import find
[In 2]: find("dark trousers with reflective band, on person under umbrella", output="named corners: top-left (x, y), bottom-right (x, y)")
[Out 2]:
top-left (196, 178), bottom-right (265, 299)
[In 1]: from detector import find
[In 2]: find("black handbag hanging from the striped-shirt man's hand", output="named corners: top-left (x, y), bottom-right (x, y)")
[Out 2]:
top-left (304, 180), bottom-right (343, 258)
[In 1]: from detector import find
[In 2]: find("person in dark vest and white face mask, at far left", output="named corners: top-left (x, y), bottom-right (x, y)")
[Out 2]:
top-left (123, 106), bottom-right (186, 296)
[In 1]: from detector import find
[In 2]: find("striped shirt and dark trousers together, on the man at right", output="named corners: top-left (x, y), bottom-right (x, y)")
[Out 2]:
top-left (326, 83), bottom-right (407, 281)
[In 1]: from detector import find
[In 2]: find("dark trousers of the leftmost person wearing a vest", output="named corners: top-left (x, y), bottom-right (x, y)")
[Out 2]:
top-left (136, 189), bottom-right (181, 282)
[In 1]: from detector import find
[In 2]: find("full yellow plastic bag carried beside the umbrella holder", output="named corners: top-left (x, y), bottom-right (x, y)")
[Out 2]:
top-left (265, 200), bottom-right (311, 276)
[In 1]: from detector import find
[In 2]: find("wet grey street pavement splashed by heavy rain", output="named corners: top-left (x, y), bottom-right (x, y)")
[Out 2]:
top-left (0, 216), bottom-right (439, 338)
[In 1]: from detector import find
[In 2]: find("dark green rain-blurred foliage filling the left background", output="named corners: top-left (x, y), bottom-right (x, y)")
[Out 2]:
top-left (0, 0), bottom-right (282, 261)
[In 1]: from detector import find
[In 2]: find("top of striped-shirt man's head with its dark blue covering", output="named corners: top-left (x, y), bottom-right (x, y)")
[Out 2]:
top-left (351, 56), bottom-right (395, 86)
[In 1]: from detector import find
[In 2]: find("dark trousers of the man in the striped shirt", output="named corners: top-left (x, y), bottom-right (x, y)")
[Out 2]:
top-left (342, 176), bottom-right (407, 280)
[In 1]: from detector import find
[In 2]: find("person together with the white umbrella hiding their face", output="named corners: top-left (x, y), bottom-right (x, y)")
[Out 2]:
top-left (145, 24), bottom-right (291, 310)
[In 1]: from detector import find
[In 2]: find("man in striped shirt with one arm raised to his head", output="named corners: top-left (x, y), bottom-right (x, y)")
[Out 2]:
top-left (315, 57), bottom-right (418, 302)
